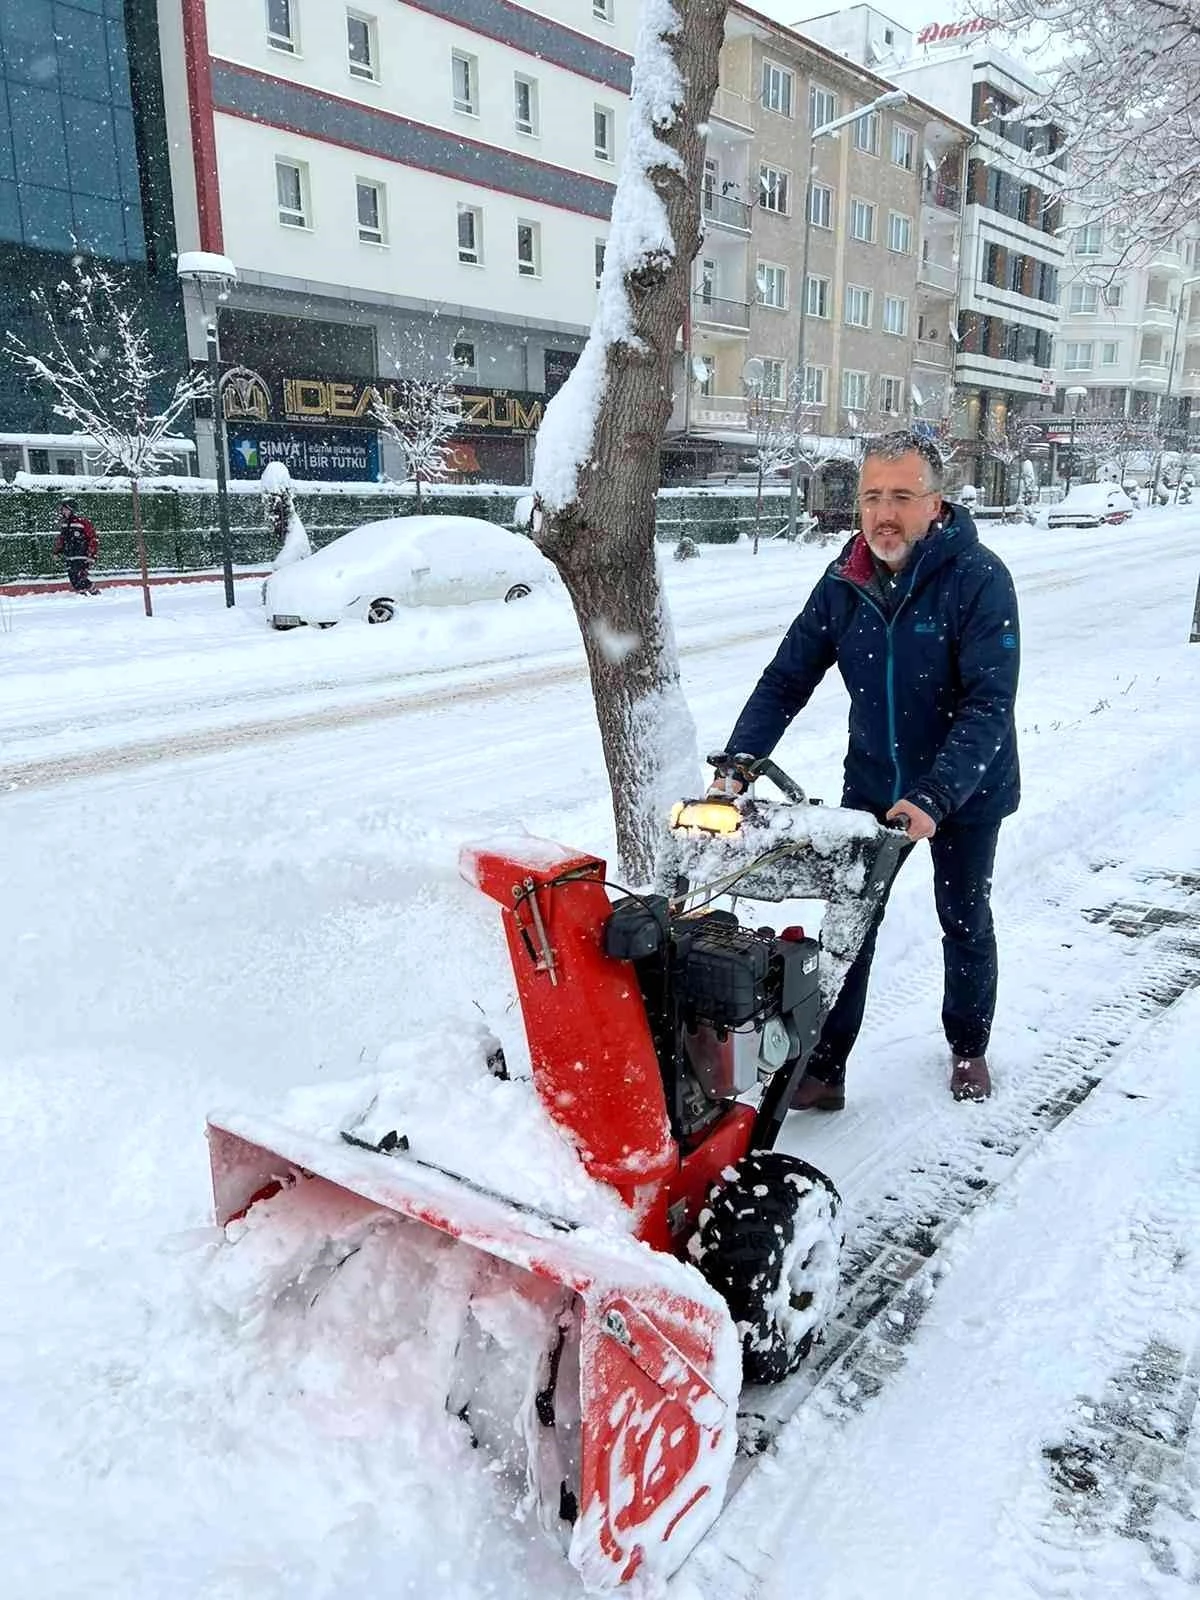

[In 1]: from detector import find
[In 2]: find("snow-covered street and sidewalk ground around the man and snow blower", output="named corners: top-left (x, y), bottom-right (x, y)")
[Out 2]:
top-left (0, 507), bottom-right (1200, 1600)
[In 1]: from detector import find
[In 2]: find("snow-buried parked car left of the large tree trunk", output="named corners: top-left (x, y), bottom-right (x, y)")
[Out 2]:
top-left (262, 517), bottom-right (557, 627)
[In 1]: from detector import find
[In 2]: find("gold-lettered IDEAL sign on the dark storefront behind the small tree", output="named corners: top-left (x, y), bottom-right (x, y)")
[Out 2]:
top-left (222, 368), bottom-right (546, 434)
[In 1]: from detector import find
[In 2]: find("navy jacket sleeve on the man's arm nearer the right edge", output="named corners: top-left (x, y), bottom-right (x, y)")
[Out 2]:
top-left (904, 566), bottom-right (1021, 822)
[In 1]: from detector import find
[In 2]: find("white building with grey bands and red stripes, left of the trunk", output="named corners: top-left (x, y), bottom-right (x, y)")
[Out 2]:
top-left (158, 0), bottom-right (638, 482)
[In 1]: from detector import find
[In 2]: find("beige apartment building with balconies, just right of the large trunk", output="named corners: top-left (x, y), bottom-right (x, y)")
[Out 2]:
top-left (672, 6), bottom-right (971, 483)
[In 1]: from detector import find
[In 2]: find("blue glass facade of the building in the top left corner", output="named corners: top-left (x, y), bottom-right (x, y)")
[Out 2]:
top-left (0, 0), bottom-right (146, 262)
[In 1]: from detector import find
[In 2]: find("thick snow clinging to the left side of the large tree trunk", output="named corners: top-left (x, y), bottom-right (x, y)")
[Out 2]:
top-left (533, 0), bottom-right (685, 512)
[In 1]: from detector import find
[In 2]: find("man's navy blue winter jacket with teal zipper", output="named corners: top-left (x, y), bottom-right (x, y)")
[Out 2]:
top-left (726, 502), bottom-right (1021, 822)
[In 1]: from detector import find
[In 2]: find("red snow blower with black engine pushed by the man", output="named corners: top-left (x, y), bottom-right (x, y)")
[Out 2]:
top-left (208, 755), bottom-right (902, 1590)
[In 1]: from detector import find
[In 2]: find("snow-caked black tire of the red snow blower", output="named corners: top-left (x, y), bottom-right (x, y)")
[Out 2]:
top-left (688, 1150), bottom-right (842, 1384)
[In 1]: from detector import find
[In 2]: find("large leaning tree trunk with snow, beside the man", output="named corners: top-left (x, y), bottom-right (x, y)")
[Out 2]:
top-left (533, 0), bottom-right (726, 883)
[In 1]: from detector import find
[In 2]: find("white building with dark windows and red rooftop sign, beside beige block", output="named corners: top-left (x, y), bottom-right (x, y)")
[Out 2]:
top-left (798, 6), bottom-right (1066, 496)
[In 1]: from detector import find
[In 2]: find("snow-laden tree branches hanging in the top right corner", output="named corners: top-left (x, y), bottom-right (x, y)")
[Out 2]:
top-left (976, 0), bottom-right (1200, 251)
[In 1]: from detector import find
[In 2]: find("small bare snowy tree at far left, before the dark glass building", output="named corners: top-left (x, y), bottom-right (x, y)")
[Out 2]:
top-left (5, 256), bottom-right (210, 616)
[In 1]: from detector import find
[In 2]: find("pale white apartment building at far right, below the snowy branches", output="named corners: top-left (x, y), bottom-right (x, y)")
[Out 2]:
top-left (1054, 211), bottom-right (1200, 446)
